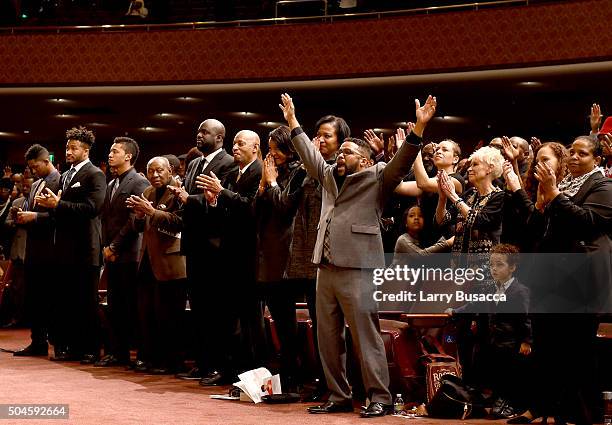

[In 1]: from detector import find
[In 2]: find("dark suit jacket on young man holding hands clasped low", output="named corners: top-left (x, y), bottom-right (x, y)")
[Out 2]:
top-left (101, 168), bottom-right (150, 263)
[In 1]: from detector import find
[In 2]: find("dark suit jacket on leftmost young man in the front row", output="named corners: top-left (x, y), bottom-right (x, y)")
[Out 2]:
top-left (25, 170), bottom-right (61, 265)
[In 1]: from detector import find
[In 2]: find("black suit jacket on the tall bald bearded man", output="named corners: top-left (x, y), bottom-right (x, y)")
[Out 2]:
top-left (181, 150), bottom-right (238, 256)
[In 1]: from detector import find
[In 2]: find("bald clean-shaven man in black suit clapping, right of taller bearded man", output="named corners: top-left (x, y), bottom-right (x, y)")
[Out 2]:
top-left (197, 130), bottom-right (265, 386)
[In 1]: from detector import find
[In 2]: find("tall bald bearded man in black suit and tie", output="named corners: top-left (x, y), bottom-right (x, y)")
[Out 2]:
top-left (168, 119), bottom-right (236, 380)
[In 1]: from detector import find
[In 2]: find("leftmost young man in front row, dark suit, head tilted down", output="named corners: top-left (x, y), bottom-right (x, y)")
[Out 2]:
top-left (13, 144), bottom-right (60, 356)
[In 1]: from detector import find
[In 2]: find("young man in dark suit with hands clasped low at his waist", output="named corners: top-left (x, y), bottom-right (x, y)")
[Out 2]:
top-left (96, 137), bottom-right (149, 366)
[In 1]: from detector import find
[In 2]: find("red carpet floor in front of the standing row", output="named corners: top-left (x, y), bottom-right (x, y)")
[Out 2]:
top-left (0, 329), bottom-right (544, 425)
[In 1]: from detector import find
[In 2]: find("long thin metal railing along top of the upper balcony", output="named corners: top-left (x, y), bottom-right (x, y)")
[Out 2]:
top-left (0, 0), bottom-right (533, 34)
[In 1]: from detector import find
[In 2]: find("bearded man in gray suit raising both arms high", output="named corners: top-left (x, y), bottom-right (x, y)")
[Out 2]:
top-left (280, 94), bottom-right (436, 417)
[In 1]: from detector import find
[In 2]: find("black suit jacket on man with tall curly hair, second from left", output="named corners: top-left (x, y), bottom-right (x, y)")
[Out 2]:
top-left (53, 162), bottom-right (106, 266)
